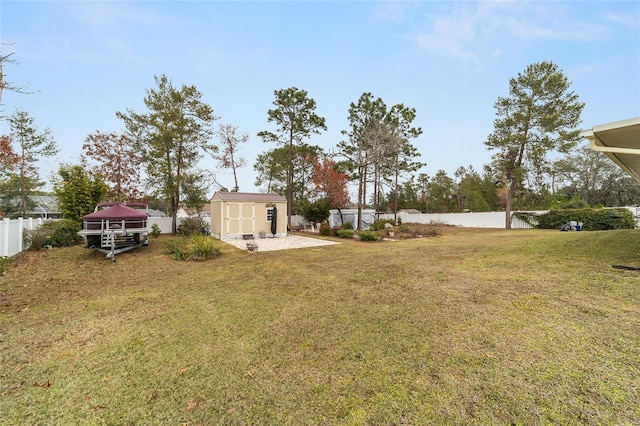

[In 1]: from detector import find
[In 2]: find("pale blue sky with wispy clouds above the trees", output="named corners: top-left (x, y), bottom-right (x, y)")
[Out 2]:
top-left (0, 0), bottom-right (640, 196)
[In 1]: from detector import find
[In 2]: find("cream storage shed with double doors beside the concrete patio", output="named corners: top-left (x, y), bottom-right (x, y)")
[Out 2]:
top-left (211, 192), bottom-right (287, 240)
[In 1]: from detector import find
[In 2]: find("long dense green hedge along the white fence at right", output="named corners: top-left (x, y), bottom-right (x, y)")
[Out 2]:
top-left (537, 208), bottom-right (636, 231)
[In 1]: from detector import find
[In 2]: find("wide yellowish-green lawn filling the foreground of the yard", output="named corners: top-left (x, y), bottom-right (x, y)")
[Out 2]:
top-left (0, 228), bottom-right (640, 425)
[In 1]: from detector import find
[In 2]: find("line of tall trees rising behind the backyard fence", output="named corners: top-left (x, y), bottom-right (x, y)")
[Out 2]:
top-left (5, 56), bottom-right (640, 226)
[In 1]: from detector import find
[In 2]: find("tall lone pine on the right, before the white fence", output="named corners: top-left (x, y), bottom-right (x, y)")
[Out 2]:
top-left (485, 62), bottom-right (584, 229)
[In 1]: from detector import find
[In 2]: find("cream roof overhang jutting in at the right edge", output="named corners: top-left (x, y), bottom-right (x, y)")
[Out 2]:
top-left (582, 117), bottom-right (640, 183)
